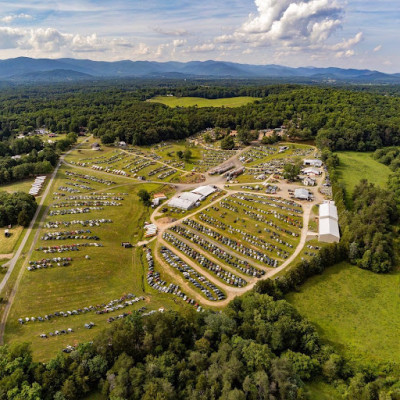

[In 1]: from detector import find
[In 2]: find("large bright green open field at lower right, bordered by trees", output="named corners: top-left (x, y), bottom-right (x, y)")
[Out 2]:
top-left (287, 263), bottom-right (400, 365)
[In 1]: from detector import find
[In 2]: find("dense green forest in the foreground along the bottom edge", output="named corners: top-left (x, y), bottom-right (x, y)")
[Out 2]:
top-left (0, 293), bottom-right (400, 400)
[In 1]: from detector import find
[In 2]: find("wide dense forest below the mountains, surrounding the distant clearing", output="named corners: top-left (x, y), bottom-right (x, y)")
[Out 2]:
top-left (0, 84), bottom-right (400, 151)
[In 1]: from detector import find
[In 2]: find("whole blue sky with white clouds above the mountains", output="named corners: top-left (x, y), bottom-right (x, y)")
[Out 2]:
top-left (0, 0), bottom-right (400, 72)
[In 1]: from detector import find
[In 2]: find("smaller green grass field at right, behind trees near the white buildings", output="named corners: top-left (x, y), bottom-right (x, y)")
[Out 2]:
top-left (337, 151), bottom-right (392, 195)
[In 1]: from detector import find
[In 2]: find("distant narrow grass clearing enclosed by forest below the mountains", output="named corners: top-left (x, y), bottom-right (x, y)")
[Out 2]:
top-left (149, 96), bottom-right (260, 107)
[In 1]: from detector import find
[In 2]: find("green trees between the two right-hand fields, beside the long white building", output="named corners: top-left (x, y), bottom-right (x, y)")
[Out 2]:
top-left (322, 150), bottom-right (400, 273)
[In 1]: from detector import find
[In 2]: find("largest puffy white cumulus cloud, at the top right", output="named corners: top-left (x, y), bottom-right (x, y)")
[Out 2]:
top-left (214, 0), bottom-right (362, 56)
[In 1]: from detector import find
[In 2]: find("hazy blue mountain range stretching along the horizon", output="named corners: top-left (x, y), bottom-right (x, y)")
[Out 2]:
top-left (0, 57), bottom-right (400, 84)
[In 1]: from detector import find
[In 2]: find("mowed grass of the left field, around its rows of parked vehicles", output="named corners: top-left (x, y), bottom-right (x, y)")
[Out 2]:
top-left (5, 160), bottom-right (189, 361)
